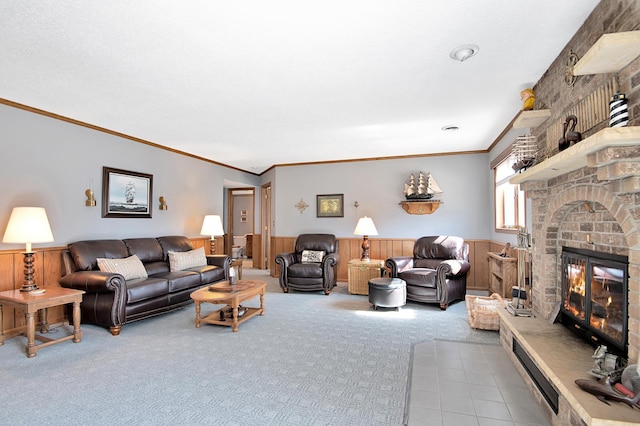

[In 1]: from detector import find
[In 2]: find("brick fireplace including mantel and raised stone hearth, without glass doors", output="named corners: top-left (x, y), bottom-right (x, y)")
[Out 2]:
top-left (500, 126), bottom-right (640, 425)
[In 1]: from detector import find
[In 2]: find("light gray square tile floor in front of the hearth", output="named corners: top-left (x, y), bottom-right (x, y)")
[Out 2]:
top-left (405, 340), bottom-right (550, 426)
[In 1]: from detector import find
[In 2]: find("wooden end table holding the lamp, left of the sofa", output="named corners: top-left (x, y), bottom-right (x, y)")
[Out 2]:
top-left (0, 287), bottom-right (84, 358)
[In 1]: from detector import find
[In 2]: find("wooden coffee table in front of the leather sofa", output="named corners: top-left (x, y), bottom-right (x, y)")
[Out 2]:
top-left (191, 280), bottom-right (267, 332)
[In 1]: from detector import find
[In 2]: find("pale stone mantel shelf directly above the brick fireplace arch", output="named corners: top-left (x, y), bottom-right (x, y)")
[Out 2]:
top-left (509, 126), bottom-right (640, 184)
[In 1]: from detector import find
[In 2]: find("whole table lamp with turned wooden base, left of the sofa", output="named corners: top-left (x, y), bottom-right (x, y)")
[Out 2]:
top-left (2, 207), bottom-right (53, 291)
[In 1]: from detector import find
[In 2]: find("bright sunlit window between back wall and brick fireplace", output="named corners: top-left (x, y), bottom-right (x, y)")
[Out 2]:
top-left (493, 149), bottom-right (526, 232)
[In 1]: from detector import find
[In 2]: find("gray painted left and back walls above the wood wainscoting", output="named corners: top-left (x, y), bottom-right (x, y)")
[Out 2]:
top-left (0, 105), bottom-right (500, 249)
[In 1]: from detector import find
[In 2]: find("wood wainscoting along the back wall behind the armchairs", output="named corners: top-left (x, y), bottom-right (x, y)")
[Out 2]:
top-left (269, 237), bottom-right (490, 290)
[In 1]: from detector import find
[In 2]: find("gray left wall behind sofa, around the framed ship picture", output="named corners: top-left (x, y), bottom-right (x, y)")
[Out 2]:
top-left (0, 105), bottom-right (259, 249)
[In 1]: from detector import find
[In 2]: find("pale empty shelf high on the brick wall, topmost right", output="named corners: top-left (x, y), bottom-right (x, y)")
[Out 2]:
top-left (573, 31), bottom-right (640, 75)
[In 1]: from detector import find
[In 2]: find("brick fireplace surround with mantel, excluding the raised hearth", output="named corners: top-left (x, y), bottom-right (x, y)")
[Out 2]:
top-left (522, 127), bottom-right (640, 360)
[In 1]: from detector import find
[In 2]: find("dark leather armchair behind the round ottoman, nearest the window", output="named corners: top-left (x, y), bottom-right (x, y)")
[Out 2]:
top-left (385, 235), bottom-right (470, 310)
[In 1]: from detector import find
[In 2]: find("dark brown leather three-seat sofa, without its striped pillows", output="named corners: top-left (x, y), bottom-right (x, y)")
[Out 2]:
top-left (60, 236), bottom-right (231, 336)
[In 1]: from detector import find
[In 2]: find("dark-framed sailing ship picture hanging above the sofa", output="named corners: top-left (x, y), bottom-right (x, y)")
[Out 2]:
top-left (102, 167), bottom-right (153, 218)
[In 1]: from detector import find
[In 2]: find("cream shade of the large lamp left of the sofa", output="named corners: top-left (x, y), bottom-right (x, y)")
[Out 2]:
top-left (2, 207), bottom-right (53, 251)
